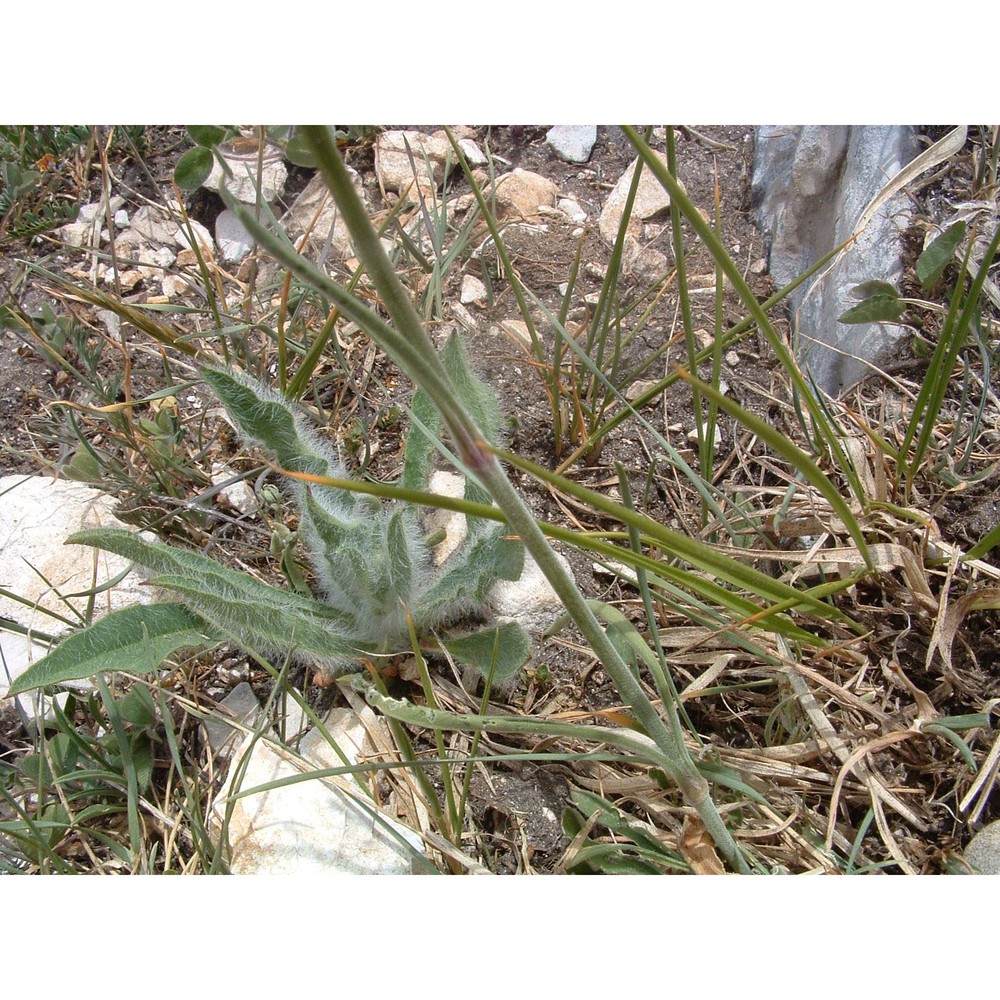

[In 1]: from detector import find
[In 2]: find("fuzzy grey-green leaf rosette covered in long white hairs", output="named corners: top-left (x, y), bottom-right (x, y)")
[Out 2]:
top-left (11, 337), bottom-right (530, 693)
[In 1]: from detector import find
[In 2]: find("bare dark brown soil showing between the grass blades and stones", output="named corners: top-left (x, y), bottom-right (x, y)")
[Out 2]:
top-left (0, 126), bottom-right (1000, 871)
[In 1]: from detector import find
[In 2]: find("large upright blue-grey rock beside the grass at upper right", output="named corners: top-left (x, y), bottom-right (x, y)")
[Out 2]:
top-left (753, 125), bottom-right (918, 396)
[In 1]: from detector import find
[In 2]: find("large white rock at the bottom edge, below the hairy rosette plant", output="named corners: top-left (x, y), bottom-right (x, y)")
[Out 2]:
top-left (212, 709), bottom-right (422, 875)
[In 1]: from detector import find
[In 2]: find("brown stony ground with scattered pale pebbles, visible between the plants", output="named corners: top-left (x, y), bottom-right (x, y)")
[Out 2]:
top-left (0, 126), bottom-right (1000, 871)
